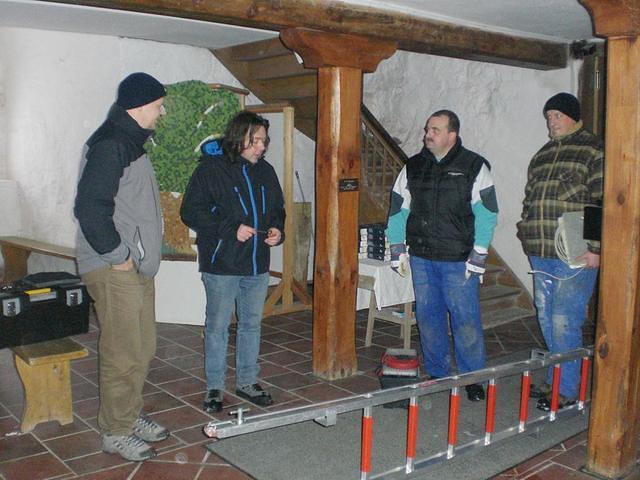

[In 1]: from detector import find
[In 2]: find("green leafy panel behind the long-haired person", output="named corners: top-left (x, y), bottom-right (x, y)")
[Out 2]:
top-left (145, 80), bottom-right (240, 193)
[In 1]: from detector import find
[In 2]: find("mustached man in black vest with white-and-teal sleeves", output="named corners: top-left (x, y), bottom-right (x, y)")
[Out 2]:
top-left (387, 110), bottom-right (498, 401)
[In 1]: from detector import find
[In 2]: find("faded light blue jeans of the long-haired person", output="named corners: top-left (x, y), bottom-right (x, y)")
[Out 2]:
top-left (202, 273), bottom-right (269, 390)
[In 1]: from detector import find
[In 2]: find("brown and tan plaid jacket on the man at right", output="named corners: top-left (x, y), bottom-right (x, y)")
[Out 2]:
top-left (518, 122), bottom-right (604, 258)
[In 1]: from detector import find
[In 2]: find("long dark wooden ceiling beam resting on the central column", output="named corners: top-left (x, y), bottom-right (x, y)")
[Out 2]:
top-left (49, 0), bottom-right (568, 70)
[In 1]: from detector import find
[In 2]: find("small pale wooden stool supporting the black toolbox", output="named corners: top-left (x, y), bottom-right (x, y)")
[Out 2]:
top-left (11, 338), bottom-right (89, 433)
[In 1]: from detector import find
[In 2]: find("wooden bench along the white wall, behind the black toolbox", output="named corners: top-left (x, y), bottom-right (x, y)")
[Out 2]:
top-left (0, 237), bottom-right (76, 283)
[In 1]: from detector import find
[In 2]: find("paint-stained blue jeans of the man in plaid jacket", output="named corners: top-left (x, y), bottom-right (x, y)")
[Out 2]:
top-left (529, 257), bottom-right (598, 398)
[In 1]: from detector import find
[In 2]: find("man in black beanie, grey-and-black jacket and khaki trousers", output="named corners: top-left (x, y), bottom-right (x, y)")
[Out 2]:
top-left (74, 72), bottom-right (169, 461)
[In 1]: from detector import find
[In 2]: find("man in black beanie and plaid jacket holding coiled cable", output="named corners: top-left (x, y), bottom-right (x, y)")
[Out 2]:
top-left (518, 93), bottom-right (603, 411)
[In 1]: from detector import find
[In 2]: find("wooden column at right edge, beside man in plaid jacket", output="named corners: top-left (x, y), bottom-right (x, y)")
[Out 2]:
top-left (582, 0), bottom-right (640, 478)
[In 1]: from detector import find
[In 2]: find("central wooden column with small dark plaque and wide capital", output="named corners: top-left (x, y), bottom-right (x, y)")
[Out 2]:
top-left (280, 28), bottom-right (396, 380)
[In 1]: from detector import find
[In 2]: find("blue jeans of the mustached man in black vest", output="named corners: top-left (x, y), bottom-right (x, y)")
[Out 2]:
top-left (410, 256), bottom-right (486, 377)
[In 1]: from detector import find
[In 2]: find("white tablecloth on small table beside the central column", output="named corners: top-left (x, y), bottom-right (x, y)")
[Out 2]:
top-left (356, 258), bottom-right (414, 310)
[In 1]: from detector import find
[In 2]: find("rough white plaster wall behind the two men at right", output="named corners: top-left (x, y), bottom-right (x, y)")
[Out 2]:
top-left (363, 52), bottom-right (578, 290)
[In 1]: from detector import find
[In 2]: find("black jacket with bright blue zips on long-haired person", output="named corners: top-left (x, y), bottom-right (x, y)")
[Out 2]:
top-left (180, 140), bottom-right (285, 276)
